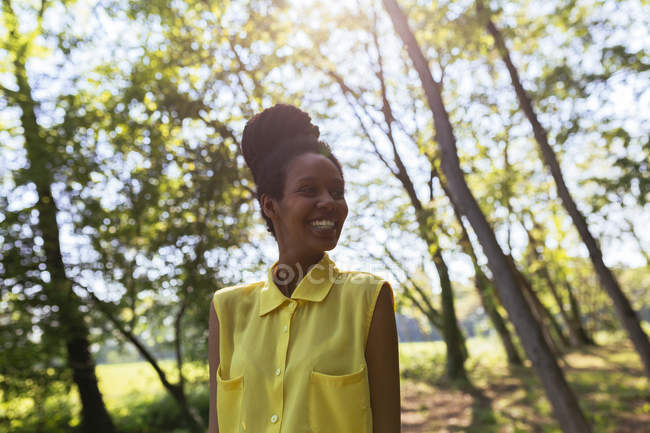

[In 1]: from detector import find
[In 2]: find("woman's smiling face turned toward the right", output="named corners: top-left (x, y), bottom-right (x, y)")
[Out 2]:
top-left (267, 153), bottom-right (348, 257)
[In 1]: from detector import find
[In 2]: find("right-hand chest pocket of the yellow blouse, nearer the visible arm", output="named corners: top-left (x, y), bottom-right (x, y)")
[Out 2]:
top-left (309, 366), bottom-right (372, 433)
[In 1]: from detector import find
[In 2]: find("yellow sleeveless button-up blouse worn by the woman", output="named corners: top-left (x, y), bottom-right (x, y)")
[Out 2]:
top-left (211, 252), bottom-right (395, 433)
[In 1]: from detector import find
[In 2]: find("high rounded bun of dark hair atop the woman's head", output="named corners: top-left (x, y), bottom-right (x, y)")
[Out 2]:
top-left (241, 104), bottom-right (320, 178)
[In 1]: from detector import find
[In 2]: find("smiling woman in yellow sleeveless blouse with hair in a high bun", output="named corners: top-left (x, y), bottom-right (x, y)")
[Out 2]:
top-left (209, 104), bottom-right (400, 433)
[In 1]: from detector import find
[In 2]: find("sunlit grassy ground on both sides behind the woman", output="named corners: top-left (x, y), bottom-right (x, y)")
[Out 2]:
top-left (0, 334), bottom-right (650, 433)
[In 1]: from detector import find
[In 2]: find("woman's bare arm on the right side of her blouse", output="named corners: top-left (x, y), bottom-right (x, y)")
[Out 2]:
top-left (366, 283), bottom-right (401, 433)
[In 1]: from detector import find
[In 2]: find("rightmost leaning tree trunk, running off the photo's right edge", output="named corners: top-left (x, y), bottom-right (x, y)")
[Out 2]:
top-left (477, 1), bottom-right (650, 379)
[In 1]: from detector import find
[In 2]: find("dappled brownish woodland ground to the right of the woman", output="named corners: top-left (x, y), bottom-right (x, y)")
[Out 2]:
top-left (401, 341), bottom-right (650, 433)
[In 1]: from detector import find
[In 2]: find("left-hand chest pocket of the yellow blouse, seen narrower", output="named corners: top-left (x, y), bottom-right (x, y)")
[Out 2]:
top-left (217, 365), bottom-right (245, 433)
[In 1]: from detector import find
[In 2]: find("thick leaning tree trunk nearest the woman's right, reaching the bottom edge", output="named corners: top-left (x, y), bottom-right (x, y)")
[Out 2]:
top-left (383, 0), bottom-right (591, 433)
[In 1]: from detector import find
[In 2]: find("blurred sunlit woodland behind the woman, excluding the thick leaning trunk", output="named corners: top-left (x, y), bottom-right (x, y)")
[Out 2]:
top-left (0, 0), bottom-right (650, 433)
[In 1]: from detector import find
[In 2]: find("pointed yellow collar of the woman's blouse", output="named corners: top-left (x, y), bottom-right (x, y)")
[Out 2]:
top-left (259, 252), bottom-right (339, 316)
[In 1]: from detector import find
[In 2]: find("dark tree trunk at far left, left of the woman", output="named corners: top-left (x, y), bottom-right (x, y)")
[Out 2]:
top-left (10, 38), bottom-right (115, 433)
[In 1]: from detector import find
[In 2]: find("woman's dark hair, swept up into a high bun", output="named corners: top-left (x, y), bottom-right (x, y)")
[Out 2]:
top-left (241, 104), bottom-right (343, 237)
